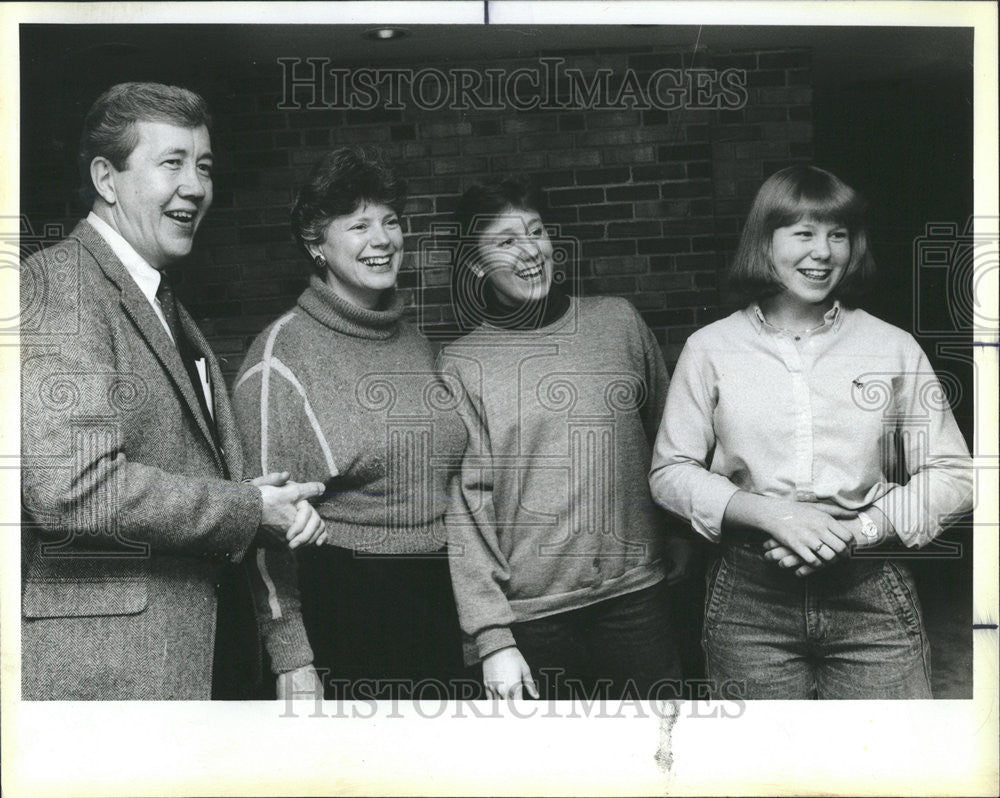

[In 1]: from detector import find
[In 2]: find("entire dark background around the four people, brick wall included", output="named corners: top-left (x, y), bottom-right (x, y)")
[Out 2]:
top-left (15, 26), bottom-right (980, 698)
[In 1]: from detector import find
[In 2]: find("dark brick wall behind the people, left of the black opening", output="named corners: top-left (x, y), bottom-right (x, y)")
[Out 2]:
top-left (22, 49), bottom-right (813, 388)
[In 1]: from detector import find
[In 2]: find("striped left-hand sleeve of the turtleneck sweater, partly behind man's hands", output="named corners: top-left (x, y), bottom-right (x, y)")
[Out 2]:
top-left (233, 350), bottom-right (336, 673)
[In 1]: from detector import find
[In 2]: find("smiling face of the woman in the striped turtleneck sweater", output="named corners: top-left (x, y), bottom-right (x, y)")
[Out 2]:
top-left (309, 202), bottom-right (403, 310)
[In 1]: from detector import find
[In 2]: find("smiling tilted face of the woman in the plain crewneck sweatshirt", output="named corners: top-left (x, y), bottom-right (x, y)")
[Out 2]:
top-left (477, 208), bottom-right (552, 306)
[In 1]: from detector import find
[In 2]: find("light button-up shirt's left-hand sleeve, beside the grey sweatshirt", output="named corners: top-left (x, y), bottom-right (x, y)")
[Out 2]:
top-left (649, 334), bottom-right (739, 542)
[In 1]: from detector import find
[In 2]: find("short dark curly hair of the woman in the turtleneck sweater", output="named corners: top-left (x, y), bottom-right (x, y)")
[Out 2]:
top-left (291, 146), bottom-right (406, 268)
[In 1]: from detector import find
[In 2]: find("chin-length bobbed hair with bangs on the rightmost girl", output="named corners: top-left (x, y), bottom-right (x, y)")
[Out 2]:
top-left (729, 165), bottom-right (875, 300)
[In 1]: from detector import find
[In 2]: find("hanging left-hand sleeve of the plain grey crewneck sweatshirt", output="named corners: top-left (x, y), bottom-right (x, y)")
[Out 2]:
top-left (439, 354), bottom-right (515, 659)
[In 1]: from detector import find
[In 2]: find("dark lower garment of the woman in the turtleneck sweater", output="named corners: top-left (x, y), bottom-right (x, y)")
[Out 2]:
top-left (299, 546), bottom-right (465, 700)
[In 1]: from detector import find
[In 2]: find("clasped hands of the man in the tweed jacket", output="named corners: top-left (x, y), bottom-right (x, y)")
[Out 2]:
top-left (250, 471), bottom-right (327, 549)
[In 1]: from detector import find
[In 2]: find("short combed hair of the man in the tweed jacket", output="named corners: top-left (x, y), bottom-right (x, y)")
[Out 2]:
top-left (77, 83), bottom-right (212, 207)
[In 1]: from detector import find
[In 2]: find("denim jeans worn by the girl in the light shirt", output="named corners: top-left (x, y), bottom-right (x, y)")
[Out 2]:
top-left (702, 545), bottom-right (931, 699)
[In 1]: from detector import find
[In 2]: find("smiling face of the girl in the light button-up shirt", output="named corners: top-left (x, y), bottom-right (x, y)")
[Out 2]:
top-left (771, 217), bottom-right (851, 310)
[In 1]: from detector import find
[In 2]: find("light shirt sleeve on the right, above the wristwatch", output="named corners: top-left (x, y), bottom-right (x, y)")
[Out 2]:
top-left (871, 336), bottom-right (973, 547)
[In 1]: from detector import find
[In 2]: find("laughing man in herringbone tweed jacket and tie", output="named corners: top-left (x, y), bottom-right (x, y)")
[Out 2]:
top-left (21, 83), bottom-right (324, 700)
